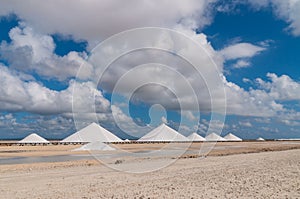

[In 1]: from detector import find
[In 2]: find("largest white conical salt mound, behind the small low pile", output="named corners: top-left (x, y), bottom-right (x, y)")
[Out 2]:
top-left (61, 123), bottom-right (123, 142)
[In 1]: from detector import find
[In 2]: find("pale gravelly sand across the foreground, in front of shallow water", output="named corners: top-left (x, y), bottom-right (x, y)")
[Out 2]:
top-left (0, 142), bottom-right (300, 198)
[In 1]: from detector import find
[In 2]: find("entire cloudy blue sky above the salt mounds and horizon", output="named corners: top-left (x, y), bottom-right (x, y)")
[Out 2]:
top-left (0, 0), bottom-right (300, 139)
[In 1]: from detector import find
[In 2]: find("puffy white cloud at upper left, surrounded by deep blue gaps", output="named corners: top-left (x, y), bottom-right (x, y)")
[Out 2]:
top-left (0, 24), bottom-right (92, 81)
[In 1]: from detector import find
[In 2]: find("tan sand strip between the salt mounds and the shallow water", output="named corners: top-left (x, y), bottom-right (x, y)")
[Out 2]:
top-left (0, 141), bottom-right (300, 157)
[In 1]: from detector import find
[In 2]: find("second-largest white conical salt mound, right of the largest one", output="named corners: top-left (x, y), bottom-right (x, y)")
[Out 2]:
top-left (138, 124), bottom-right (189, 142)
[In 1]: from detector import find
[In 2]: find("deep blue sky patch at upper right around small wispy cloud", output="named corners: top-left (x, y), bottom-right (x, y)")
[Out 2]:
top-left (203, 6), bottom-right (300, 83)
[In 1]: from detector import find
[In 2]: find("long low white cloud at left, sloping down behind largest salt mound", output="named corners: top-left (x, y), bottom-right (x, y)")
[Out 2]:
top-left (0, 62), bottom-right (147, 136)
